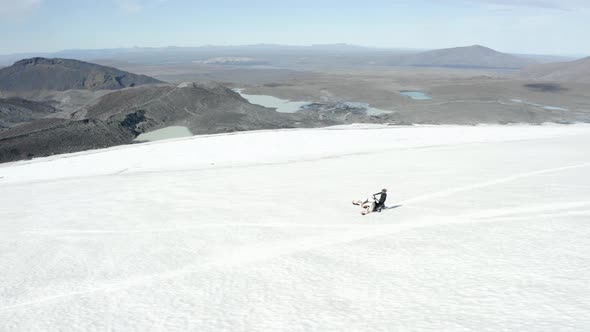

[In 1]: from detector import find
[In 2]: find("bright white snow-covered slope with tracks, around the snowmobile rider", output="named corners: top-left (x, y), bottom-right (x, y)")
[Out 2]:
top-left (0, 125), bottom-right (590, 331)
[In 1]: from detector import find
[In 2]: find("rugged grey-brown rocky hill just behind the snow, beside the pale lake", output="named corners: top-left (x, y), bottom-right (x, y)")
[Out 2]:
top-left (83, 82), bottom-right (292, 134)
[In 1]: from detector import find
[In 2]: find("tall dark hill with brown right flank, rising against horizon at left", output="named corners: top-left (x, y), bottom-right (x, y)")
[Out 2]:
top-left (0, 58), bottom-right (162, 92)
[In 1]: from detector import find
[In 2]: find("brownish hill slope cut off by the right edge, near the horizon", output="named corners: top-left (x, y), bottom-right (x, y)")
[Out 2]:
top-left (522, 57), bottom-right (590, 83)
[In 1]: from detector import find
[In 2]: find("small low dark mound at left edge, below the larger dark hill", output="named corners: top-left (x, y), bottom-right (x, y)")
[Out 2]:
top-left (0, 98), bottom-right (59, 130)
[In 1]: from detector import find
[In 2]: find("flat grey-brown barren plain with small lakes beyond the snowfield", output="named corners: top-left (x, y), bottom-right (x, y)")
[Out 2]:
top-left (110, 64), bottom-right (590, 124)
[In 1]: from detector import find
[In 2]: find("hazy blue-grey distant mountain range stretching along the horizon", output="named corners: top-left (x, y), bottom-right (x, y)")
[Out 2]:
top-left (0, 44), bottom-right (570, 69)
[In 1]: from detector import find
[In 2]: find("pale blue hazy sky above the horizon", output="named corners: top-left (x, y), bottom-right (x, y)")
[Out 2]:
top-left (0, 0), bottom-right (590, 55)
